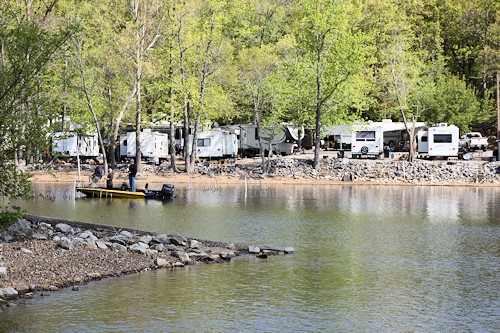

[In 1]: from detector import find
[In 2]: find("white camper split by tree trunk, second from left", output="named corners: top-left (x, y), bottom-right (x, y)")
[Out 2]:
top-left (120, 130), bottom-right (168, 164)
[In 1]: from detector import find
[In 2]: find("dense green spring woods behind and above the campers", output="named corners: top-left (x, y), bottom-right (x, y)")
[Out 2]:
top-left (0, 0), bottom-right (500, 197)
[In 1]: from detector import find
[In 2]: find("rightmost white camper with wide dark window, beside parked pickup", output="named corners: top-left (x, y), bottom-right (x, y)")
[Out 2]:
top-left (418, 123), bottom-right (459, 159)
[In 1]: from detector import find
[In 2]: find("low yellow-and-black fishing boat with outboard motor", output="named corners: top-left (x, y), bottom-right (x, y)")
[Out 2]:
top-left (76, 184), bottom-right (175, 200)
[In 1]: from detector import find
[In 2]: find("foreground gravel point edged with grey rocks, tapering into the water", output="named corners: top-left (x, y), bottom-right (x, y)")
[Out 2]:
top-left (0, 216), bottom-right (293, 310)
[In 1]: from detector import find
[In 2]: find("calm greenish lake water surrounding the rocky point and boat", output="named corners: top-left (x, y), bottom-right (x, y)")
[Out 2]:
top-left (0, 184), bottom-right (500, 332)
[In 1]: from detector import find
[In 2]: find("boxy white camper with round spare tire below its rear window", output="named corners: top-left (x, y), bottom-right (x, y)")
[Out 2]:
top-left (351, 125), bottom-right (384, 158)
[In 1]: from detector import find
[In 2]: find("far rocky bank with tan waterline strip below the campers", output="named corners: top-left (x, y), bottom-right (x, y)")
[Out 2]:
top-left (28, 155), bottom-right (500, 186)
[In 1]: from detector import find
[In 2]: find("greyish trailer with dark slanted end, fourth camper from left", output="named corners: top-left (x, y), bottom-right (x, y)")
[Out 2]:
top-left (223, 124), bottom-right (304, 157)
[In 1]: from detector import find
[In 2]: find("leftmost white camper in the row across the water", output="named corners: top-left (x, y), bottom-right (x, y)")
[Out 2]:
top-left (52, 132), bottom-right (99, 158)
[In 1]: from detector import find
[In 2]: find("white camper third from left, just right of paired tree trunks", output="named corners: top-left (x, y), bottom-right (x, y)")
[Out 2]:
top-left (189, 127), bottom-right (238, 159)
